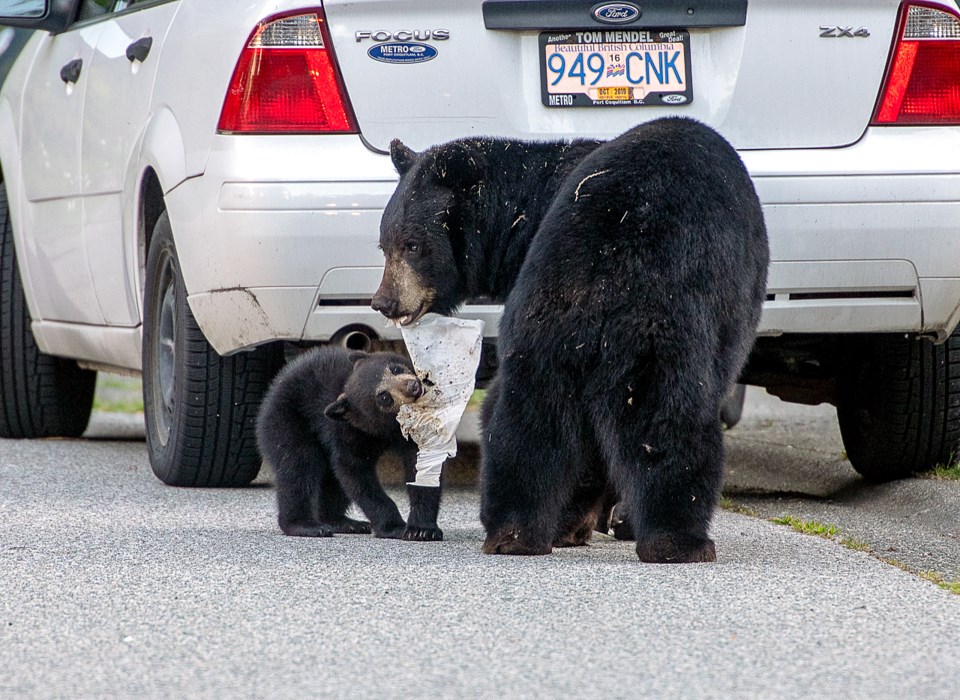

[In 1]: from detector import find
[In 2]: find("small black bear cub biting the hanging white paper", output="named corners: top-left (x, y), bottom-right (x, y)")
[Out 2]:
top-left (257, 347), bottom-right (443, 540)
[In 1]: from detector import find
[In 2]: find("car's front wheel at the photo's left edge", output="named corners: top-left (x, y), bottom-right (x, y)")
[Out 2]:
top-left (0, 183), bottom-right (97, 438)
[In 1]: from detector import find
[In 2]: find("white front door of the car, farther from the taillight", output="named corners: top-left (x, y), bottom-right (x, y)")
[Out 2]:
top-left (17, 3), bottom-right (103, 324)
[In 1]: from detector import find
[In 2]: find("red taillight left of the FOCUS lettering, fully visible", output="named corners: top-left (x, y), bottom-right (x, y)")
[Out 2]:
top-left (217, 10), bottom-right (357, 134)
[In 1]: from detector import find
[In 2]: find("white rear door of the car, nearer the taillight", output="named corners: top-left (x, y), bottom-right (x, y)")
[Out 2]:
top-left (81, 0), bottom-right (179, 326)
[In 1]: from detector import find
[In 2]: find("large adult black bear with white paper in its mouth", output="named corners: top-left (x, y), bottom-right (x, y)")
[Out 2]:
top-left (373, 118), bottom-right (769, 562)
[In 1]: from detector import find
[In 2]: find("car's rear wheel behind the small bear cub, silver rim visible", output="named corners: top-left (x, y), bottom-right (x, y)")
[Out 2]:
top-left (143, 212), bottom-right (283, 486)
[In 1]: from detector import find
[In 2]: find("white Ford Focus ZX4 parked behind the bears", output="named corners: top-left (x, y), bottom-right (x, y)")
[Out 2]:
top-left (0, 0), bottom-right (960, 485)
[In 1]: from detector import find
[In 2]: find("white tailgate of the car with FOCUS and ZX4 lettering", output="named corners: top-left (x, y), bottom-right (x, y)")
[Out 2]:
top-left (324, 0), bottom-right (899, 149)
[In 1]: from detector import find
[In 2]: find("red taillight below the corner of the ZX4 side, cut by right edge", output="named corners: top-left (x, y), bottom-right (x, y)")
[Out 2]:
top-left (872, 3), bottom-right (960, 125)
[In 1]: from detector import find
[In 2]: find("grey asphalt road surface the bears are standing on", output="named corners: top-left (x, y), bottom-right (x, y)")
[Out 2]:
top-left (0, 395), bottom-right (960, 698)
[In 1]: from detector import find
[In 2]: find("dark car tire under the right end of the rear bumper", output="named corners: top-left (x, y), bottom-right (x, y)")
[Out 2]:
top-left (837, 331), bottom-right (960, 481)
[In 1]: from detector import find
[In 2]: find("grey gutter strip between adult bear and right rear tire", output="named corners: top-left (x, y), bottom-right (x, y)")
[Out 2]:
top-left (724, 387), bottom-right (960, 581)
